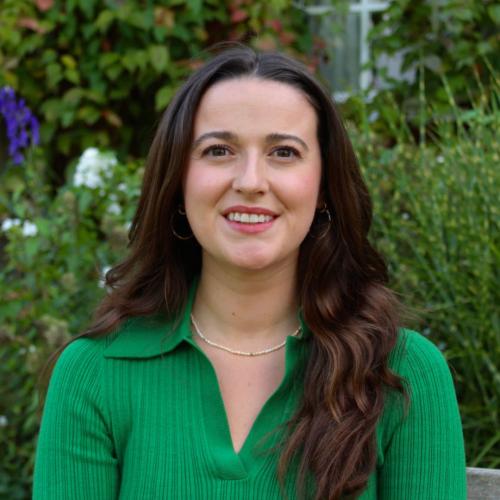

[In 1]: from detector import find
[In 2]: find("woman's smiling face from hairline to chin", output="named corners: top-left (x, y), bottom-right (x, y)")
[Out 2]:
top-left (183, 77), bottom-right (321, 271)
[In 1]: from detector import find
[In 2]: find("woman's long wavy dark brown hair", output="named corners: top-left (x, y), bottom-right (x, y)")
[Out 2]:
top-left (39, 46), bottom-right (408, 500)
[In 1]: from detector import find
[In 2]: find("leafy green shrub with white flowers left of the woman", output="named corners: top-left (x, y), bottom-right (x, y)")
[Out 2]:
top-left (0, 148), bottom-right (142, 500)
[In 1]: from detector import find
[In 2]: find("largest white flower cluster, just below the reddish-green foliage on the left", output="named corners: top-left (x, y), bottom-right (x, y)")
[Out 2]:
top-left (73, 148), bottom-right (117, 189)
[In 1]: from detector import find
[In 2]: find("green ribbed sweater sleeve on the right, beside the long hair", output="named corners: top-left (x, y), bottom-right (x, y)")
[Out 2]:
top-left (377, 331), bottom-right (467, 500)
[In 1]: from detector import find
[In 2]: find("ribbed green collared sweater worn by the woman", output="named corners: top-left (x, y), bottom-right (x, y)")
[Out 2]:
top-left (33, 287), bottom-right (466, 500)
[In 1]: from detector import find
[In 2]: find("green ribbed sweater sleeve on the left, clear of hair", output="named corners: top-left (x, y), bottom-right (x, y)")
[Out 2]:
top-left (33, 338), bottom-right (119, 500)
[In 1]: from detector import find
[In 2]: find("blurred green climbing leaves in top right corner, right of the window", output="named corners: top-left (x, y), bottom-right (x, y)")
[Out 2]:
top-left (368, 0), bottom-right (500, 128)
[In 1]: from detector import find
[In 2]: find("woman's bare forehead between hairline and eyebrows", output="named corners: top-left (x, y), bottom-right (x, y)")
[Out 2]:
top-left (194, 77), bottom-right (317, 136)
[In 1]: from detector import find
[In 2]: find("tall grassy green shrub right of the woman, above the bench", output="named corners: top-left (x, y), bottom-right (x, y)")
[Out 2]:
top-left (355, 89), bottom-right (500, 468)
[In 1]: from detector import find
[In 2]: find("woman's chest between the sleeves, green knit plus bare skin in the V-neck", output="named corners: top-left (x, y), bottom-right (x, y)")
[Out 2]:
top-left (103, 348), bottom-right (378, 500)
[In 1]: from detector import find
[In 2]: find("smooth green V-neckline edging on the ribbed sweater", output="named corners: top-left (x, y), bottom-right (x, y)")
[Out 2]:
top-left (189, 336), bottom-right (304, 479)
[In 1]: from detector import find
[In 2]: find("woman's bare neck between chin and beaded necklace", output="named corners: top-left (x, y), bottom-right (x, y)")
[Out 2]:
top-left (193, 265), bottom-right (298, 348)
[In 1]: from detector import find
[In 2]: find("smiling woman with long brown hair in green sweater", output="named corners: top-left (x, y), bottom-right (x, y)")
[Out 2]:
top-left (34, 47), bottom-right (465, 500)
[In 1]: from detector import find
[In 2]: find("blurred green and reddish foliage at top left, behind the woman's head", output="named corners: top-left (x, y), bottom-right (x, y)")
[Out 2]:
top-left (0, 0), bottom-right (311, 183)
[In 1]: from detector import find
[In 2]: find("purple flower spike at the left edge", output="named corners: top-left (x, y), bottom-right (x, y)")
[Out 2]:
top-left (0, 87), bottom-right (40, 165)
